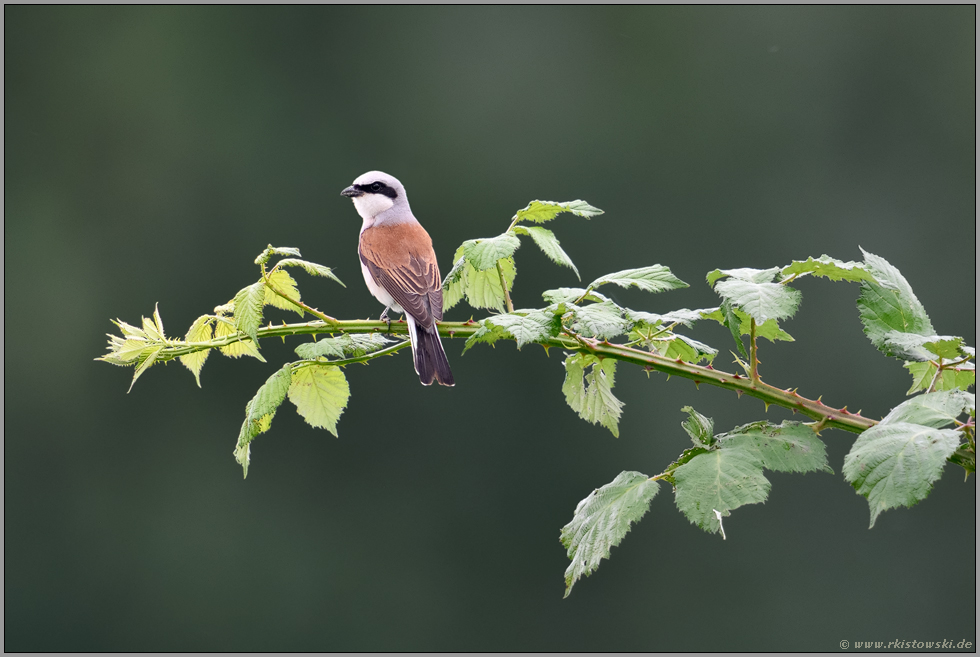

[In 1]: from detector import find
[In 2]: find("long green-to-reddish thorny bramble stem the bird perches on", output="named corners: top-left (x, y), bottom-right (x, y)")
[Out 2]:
top-left (147, 319), bottom-right (877, 433)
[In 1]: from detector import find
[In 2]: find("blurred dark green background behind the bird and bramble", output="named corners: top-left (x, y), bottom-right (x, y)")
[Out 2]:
top-left (4, 6), bottom-right (976, 651)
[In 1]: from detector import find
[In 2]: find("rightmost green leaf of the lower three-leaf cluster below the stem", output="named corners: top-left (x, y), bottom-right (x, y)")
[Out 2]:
top-left (718, 422), bottom-right (834, 474)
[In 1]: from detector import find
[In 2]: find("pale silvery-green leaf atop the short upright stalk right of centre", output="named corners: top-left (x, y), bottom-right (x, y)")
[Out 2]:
top-left (708, 267), bottom-right (803, 324)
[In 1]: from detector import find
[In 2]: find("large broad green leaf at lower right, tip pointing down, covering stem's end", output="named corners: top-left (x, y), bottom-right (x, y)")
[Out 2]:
top-left (844, 422), bottom-right (959, 527)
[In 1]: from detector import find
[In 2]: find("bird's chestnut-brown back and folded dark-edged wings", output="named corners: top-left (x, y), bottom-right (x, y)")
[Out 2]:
top-left (358, 223), bottom-right (442, 328)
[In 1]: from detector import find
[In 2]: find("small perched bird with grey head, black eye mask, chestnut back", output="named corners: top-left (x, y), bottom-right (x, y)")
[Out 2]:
top-left (340, 171), bottom-right (456, 386)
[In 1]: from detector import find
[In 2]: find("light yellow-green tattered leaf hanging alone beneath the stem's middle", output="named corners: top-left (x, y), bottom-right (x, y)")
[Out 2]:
top-left (561, 354), bottom-right (623, 438)
